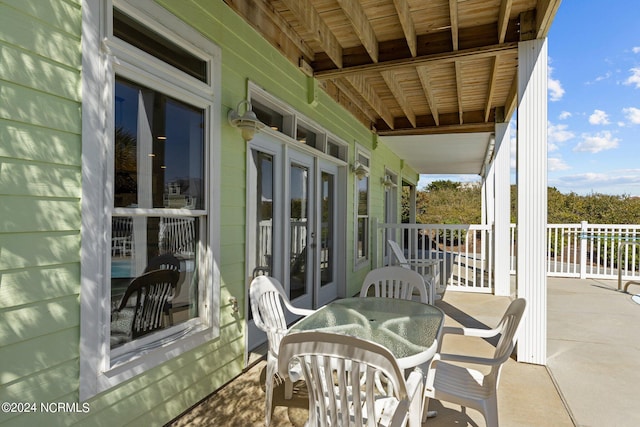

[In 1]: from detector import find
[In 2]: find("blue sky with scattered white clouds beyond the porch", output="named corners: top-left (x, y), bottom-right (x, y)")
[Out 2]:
top-left (418, 0), bottom-right (640, 196)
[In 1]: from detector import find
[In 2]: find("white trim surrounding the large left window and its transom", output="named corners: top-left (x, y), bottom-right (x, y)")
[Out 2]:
top-left (80, 0), bottom-right (221, 401)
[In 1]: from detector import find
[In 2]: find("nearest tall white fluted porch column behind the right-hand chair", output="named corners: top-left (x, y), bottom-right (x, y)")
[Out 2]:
top-left (516, 38), bottom-right (547, 365)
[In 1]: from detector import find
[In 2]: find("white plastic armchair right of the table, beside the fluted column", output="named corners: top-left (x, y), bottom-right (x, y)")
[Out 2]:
top-left (423, 298), bottom-right (526, 427)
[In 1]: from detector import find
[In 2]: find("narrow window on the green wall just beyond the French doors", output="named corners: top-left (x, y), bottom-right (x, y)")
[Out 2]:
top-left (353, 146), bottom-right (370, 268)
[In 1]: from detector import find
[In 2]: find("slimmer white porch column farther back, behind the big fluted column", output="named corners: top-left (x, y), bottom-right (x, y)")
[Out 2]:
top-left (492, 123), bottom-right (511, 296)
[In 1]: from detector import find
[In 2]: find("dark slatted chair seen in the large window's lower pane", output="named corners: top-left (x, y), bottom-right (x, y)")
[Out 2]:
top-left (111, 270), bottom-right (180, 347)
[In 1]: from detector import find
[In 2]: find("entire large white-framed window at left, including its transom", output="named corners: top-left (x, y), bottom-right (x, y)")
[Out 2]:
top-left (80, 0), bottom-right (220, 400)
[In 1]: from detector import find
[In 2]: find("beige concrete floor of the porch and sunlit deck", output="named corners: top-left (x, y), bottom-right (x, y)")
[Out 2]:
top-left (167, 278), bottom-right (640, 427)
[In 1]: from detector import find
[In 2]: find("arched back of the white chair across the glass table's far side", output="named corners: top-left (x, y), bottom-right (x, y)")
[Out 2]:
top-left (360, 266), bottom-right (433, 304)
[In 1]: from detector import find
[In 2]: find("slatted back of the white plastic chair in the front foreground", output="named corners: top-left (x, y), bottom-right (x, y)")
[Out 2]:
top-left (278, 331), bottom-right (423, 427)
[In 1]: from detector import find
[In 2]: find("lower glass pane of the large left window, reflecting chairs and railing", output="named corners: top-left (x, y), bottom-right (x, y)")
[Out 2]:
top-left (111, 216), bottom-right (200, 349)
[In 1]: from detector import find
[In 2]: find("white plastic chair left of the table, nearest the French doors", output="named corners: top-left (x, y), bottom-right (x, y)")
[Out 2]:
top-left (249, 276), bottom-right (314, 426)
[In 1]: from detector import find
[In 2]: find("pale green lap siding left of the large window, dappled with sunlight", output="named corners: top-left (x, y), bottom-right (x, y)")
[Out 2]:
top-left (0, 0), bottom-right (81, 425)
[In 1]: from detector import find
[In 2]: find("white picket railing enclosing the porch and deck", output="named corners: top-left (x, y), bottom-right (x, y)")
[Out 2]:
top-left (374, 221), bottom-right (640, 292)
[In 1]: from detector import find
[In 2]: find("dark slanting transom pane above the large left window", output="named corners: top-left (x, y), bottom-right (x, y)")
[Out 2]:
top-left (113, 9), bottom-right (208, 83)
